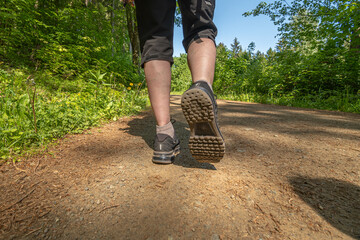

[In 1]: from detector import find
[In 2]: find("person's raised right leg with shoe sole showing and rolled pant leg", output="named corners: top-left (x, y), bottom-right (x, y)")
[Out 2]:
top-left (179, 0), bottom-right (225, 162)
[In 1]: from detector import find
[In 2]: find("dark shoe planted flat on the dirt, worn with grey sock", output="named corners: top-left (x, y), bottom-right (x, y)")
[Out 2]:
top-left (152, 134), bottom-right (180, 164)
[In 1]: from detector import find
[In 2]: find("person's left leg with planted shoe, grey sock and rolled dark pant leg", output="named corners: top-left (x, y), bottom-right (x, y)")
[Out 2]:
top-left (135, 0), bottom-right (180, 164)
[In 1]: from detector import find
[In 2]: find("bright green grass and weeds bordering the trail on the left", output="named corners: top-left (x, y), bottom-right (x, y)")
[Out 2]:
top-left (0, 69), bottom-right (148, 161)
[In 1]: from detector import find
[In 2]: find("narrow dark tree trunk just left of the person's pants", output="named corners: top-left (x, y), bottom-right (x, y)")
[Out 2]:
top-left (125, 4), bottom-right (140, 69)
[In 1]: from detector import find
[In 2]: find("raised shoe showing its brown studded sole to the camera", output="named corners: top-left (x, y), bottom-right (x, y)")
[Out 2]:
top-left (181, 81), bottom-right (225, 162)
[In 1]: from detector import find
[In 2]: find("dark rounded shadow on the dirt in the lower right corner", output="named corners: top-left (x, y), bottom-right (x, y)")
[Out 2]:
top-left (289, 176), bottom-right (360, 239)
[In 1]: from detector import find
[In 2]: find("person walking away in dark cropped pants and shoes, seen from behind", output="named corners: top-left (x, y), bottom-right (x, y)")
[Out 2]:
top-left (135, 0), bottom-right (225, 164)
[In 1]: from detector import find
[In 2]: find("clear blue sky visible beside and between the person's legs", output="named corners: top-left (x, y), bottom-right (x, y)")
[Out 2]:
top-left (174, 0), bottom-right (277, 56)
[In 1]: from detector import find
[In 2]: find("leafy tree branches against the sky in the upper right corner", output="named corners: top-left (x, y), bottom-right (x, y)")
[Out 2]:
top-left (244, 0), bottom-right (360, 93)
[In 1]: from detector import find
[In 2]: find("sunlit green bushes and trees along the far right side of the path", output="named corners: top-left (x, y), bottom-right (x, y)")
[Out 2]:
top-left (172, 39), bottom-right (360, 113)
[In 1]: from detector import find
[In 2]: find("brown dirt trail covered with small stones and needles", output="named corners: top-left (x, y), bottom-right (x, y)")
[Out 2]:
top-left (0, 96), bottom-right (360, 240)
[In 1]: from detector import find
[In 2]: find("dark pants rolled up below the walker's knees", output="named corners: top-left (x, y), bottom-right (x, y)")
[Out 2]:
top-left (135, 0), bottom-right (217, 67)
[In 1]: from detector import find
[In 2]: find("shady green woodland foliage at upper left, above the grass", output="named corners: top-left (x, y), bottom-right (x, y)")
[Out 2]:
top-left (0, 0), bottom-right (141, 84)
